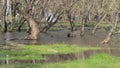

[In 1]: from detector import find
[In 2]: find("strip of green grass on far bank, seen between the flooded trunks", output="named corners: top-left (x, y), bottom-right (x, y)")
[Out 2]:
top-left (0, 22), bottom-right (116, 31)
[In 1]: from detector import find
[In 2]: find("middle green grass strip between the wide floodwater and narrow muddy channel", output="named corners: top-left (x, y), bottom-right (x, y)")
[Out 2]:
top-left (0, 44), bottom-right (100, 60)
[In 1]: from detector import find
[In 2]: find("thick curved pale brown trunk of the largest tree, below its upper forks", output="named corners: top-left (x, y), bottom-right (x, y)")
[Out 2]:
top-left (16, 0), bottom-right (40, 40)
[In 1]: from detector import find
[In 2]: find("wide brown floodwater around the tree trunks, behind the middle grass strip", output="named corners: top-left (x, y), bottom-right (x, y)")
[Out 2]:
top-left (0, 29), bottom-right (120, 47)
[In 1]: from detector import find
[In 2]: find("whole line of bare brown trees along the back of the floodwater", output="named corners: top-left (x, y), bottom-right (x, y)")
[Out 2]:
top-left (0, 0), bottom-right (120, 43)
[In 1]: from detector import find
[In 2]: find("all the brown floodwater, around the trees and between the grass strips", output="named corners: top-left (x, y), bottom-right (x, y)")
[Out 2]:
top-left (0, 29), bottom-right (120, 63)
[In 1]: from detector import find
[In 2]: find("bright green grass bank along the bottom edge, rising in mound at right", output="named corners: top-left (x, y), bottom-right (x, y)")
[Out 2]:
top-left (0, 53), bottom-right (120, 68)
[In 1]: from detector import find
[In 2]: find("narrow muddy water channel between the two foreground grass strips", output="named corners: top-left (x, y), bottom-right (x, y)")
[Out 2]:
top-left (32, 48), bottom-right (120, 63)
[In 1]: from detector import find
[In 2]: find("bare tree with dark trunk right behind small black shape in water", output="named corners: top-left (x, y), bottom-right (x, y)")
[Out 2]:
top-left (64, 0), bottom-right (79, 32)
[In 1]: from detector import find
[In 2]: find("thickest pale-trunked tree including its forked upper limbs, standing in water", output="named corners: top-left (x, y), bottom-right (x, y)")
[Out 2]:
top-left (16, 0), bottom-right (39, 40)
